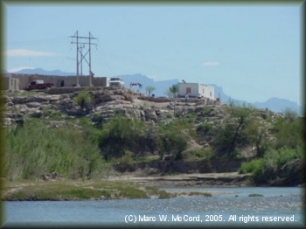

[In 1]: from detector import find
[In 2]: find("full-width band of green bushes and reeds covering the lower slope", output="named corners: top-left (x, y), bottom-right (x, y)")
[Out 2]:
top-left (5, 91), bottom-right (304, 186)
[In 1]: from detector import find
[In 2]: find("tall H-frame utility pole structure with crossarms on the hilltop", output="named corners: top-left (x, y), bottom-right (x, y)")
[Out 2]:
top-left (71, 31), bottom-right (97, 86)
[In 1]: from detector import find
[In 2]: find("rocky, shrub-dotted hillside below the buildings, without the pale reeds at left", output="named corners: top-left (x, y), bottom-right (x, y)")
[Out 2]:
top-left (2, 88), bottom-right (300, 184)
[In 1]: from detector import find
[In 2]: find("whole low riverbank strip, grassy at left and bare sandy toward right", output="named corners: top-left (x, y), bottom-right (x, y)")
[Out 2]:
top-left (2, 173), bottom-right (253, 201)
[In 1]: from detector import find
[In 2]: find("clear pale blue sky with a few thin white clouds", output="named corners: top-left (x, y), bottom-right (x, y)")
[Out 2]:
top-left (2, 2), bottom-right (302, 105)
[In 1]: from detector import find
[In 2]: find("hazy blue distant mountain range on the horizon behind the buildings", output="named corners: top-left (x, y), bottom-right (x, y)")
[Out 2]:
top-left (6, 68), bottom-right (302, 115)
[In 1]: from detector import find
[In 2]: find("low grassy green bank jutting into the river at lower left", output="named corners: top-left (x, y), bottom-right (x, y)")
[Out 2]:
top-left (2, 180), bottom-right (172, 201)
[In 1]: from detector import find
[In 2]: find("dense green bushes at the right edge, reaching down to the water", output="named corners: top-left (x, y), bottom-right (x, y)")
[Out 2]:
top-left (239, 110), bottom-right (305, 183)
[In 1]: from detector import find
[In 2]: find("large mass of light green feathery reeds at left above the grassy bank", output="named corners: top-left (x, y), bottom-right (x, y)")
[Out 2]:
top-left (5, 119), bottom-right (103, 180)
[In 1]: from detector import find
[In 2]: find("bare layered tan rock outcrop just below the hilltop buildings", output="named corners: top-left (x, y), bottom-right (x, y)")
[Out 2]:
top-left (2, 88), bottom-right (218, 126)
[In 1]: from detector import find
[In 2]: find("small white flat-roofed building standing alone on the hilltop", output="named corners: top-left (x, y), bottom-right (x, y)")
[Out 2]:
top-left (178, 83), bottom-right (215, 100)
